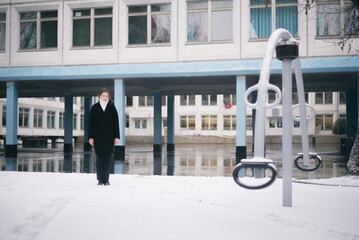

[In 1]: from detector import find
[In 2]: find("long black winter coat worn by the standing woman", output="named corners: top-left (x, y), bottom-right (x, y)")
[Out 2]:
top-left (88, 101), bottom-right (120, 153)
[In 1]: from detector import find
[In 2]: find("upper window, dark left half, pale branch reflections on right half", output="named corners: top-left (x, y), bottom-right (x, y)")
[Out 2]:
top-left (128, 4), bottom-right (171, 45)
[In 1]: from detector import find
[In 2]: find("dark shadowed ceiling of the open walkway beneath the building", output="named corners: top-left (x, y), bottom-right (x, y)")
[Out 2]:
top-left (0, 72), bottom-right (358, 98)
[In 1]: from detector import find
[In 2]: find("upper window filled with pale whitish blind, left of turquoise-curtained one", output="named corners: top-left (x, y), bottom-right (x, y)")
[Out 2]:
top-left (187, 0), bottom-right (233, 42)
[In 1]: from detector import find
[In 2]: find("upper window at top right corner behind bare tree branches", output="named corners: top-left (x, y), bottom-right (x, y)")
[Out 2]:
top-left (317, 0), bottom-right (359, 36)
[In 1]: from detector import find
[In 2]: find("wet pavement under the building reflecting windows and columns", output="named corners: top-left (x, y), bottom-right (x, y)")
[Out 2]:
top-left (0, 143), bottom-right (346, 179)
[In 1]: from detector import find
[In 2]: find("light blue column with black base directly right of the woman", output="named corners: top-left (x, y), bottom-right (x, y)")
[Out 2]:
top-left (114, 79), bottom-right (126, 160)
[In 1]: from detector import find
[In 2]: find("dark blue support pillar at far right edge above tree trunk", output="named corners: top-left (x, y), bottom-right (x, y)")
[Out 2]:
top-left (345, 79), bottom-right (359, 161)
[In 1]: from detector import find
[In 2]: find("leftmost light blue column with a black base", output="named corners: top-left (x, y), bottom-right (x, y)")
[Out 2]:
top-left (5, 82), bottom-right (18, 157)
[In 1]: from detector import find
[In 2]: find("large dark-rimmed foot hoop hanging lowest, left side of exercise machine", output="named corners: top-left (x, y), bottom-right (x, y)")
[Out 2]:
top-left (233, 163), bottom-right (277, 190)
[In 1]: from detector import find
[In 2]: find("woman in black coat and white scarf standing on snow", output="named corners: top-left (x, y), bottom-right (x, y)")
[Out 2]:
top-left (88, 88), bottom-right (120, 185)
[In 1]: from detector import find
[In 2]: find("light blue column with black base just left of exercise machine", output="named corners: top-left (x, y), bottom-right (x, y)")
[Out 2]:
top-left (236, 76), bottom-right (247, 163)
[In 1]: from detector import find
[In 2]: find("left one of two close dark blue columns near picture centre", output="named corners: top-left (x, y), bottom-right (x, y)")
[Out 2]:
top-left (153, 92), bottom-right (162, 152)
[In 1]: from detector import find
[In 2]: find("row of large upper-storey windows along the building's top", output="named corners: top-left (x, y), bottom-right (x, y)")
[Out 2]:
top-left (0, 0), bottom-right (359, 50)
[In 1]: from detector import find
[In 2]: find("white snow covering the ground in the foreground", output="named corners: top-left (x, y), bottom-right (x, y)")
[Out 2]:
top-left (0, 172), bottom-right (359, 240)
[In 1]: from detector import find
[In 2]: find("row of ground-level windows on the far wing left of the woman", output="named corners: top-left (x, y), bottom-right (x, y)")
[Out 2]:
top-left (2, 106), bottom-right (85, 130)
